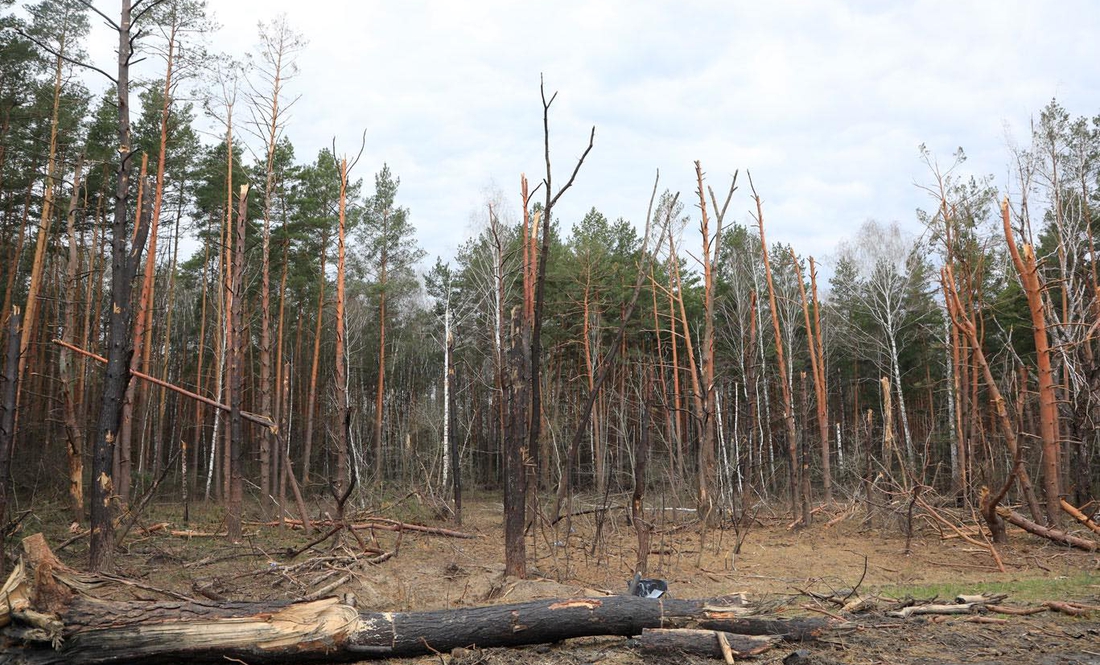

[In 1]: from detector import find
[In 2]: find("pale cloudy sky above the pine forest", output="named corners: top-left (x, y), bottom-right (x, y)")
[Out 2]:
top-left (81, 0), bottom-right (1100, 272)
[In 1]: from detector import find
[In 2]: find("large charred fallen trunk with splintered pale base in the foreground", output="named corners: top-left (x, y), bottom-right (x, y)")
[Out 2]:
top-left (0, 534), bottom-right (827, 664)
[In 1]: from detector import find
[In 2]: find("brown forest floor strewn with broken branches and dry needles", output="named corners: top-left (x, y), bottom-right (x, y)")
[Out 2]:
top-left (15, 495), bottom-right (1100, 665)
